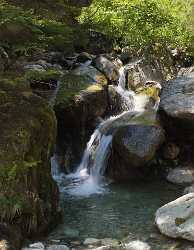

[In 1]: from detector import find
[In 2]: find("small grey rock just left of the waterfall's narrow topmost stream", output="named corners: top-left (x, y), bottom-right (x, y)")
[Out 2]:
top-left (94, 56), bottom-right (119, 82)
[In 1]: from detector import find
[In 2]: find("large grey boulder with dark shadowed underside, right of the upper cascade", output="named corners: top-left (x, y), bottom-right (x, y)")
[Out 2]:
top-left (160, 73), bottom-right (194, 143)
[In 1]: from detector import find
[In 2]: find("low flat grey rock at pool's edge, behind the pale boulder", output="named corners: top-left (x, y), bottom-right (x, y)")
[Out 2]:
top-left (167, 167), bottom-right (194, 184)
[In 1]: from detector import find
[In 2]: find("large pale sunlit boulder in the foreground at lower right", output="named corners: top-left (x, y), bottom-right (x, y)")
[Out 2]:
top-left (155, 193), bottom-right (194, 241)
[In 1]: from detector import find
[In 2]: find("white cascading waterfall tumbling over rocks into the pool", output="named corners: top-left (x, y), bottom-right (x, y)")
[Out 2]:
top-left (52, 63), bottom-right (153, 196)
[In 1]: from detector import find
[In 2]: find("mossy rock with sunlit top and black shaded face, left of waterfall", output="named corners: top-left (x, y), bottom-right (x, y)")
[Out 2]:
top-left (54, 67), bottom-right (108, 172)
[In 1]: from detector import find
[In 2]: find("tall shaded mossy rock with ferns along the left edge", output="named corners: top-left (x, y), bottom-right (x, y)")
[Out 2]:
top-left (0, 81), bottom-right (58, 242)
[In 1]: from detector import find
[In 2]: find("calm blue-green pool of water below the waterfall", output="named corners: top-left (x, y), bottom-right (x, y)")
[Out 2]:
top-left (47, 181), bottom-right (191, 249)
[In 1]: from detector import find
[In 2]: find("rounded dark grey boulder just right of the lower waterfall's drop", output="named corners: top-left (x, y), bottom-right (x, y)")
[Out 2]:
top-left (108, 124), bottom-right (165, 179)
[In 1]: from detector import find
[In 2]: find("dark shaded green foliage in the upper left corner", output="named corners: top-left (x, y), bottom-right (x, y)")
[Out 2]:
top-left (0, 0), bottom-right (83, 56)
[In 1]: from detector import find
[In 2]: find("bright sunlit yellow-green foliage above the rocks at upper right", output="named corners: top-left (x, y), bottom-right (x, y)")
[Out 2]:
top-left (79, 0), bottom-right (193, 52)
